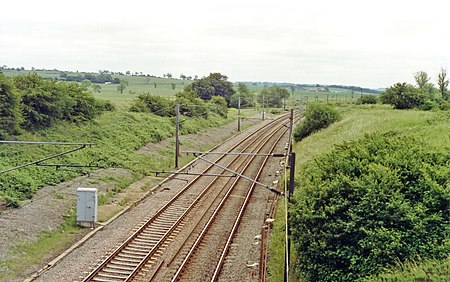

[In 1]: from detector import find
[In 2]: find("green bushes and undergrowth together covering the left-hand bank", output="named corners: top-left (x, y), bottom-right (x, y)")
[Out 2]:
top-left (0, 70), bottom-right (239, 207)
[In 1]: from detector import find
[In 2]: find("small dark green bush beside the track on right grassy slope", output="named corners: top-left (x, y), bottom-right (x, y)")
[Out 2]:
top-left (294, 104), bottom-right (341, 141)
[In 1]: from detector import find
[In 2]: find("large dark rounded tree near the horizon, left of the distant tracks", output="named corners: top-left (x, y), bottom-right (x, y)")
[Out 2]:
top-left (186, 73), bottom-right (235, 104)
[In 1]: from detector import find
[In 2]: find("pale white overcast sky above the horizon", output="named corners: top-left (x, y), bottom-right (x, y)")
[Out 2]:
top-left (0, 0), bottom-right (450, 88)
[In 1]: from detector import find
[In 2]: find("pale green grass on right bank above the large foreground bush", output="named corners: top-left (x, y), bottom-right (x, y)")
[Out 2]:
top-left (269, 105), bottom-right (450, 281)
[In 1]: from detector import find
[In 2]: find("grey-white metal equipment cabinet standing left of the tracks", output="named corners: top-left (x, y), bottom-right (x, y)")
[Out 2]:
top-left (77, 188), bottom-right (98, 227)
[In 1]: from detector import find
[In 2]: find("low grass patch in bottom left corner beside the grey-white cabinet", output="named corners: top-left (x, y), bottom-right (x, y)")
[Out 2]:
top-left (0, 209), bottom-right (82, 281)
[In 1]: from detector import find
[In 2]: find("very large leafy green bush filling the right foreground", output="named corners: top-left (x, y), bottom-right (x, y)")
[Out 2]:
top-left (291, 133), bottom-right (450, 281)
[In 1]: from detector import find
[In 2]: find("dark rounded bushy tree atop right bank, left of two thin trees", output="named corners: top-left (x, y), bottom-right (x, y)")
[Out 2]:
top-left (380, 83), bottom-right (425, 109)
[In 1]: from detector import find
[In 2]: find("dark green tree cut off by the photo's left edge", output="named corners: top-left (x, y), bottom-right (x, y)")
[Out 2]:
top-left (0, 73), bottom-right (22, 139)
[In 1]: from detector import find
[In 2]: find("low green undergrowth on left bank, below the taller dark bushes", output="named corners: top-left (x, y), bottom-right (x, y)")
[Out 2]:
top-left (0, 110), bottom-right (236, 206)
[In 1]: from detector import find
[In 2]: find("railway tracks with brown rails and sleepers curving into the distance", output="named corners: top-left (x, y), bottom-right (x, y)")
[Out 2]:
top-left (83, 113), bottom-right (288, 281)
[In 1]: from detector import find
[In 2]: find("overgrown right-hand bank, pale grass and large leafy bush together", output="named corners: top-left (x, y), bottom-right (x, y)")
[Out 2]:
top-left (270, 106), bottom-right (450, 281)
